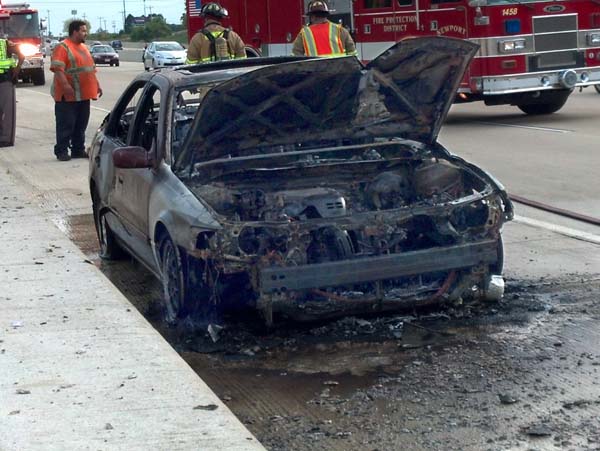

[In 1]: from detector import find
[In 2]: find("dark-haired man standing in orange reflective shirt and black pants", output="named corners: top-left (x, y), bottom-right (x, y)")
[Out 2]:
top-left (50, 20), bottom-right (102, 161)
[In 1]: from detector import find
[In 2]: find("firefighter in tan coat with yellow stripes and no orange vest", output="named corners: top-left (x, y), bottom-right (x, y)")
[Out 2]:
top-left (186, 2), bottom-right (246, 64)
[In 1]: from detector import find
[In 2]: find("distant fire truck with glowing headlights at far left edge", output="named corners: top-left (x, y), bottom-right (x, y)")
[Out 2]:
top-left (0, 3), bottom-right (46, 85)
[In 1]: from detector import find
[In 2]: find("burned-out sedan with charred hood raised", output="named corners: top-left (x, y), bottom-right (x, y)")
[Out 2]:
top-left (90, 37), bottom-right (513, 323)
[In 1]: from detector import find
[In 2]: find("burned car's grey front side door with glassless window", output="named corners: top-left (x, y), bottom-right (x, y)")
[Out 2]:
top-left (111, 81), bottom-right (164, 266)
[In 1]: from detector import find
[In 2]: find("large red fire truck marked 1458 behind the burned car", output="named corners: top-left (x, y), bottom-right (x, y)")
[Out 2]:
top-left (186, 0), bottom-right (600, 114)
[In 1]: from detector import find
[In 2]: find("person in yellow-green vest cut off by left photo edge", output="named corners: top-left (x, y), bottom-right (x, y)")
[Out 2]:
top-left (0, 37), bottom-right (25, 147)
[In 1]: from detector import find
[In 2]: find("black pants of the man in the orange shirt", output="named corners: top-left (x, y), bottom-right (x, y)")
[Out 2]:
top-left (54, 100), bottom-right (90, 155)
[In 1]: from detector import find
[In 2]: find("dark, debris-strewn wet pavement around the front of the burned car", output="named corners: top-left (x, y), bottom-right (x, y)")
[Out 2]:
top-left (65, 215), bottom-right (600, 451)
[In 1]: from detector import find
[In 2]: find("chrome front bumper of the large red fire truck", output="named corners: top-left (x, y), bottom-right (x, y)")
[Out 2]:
top-left (475, 66), bottom-right (600, 95)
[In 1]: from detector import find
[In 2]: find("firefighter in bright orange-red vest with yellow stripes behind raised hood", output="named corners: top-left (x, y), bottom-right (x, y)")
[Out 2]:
top-left (292, 0), bottom-right (357, 57)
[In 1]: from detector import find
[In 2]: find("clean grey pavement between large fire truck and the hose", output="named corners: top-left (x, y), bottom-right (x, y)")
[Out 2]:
top-left (440, 88), bottom-right (600, 218)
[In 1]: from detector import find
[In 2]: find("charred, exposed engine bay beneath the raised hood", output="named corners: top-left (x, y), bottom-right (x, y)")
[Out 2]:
top-left (185, 141), bottom-right (509, 314)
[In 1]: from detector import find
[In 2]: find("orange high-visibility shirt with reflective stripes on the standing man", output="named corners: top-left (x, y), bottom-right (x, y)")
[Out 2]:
top-left (50, 39), bottom-right (98, 102)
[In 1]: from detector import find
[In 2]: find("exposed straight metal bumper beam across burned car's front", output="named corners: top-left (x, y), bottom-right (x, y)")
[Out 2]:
top-left (259, 240), bottom-right (498, 294)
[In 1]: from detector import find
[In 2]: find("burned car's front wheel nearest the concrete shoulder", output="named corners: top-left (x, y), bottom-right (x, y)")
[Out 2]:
top-left (159, 235), bottom-right (186, 325)
